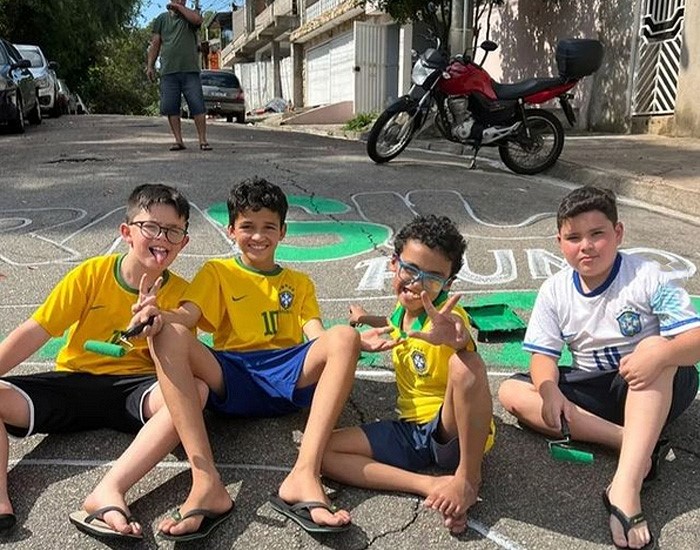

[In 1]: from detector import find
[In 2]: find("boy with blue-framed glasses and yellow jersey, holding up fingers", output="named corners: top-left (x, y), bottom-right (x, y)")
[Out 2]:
top-left (322, 215), bottom-right (494, 533)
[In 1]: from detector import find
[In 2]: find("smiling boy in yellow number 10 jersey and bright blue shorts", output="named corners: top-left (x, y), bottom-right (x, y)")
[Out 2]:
top-left (146, 179), bottom-right (400, 540)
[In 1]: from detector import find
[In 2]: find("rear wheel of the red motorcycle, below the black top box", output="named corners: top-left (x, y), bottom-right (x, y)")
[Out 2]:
top-left (498, 109), bottom-right (564, 175)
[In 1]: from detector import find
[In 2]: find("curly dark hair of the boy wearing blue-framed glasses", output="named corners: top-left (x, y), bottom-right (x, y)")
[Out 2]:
top-left (394, 214), bottom-right (467, 277)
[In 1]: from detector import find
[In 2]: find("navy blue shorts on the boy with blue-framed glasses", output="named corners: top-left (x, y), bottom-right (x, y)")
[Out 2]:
top-left (360, 411), bottom-right (459, 472)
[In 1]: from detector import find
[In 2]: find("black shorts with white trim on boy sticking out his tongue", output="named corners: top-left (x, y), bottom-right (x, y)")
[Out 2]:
top-left (0, 371), bottom-right (158, 437)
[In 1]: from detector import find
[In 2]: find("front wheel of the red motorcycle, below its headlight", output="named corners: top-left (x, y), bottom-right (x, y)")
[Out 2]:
top-left (367, 104), bottom-right (416, 163)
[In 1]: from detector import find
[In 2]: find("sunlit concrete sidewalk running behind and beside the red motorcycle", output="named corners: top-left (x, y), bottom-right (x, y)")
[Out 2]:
top-left (254, 117), bottom-right (700, 222)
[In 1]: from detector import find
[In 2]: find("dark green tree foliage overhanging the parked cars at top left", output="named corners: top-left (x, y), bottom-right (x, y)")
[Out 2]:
top-left (0, 0), bottom-right (145, 112)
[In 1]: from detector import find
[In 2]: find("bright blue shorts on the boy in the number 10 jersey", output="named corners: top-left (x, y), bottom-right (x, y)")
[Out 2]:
top-left (207, 340), bottom-right (316, 417)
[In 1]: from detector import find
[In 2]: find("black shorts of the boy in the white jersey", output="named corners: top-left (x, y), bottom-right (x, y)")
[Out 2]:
top-left (511, 367), bottom-right (698, 426)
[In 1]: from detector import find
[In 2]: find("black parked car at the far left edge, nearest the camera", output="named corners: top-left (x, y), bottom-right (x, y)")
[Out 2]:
top-left (0, 38), bottom-right (41, 133)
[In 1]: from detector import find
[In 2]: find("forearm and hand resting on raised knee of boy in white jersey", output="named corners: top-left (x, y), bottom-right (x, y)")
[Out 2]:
top-left (620, 328), bottom-right (700, 390)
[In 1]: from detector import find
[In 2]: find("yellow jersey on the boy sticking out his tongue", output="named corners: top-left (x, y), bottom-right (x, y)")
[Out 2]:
top-left (32, 254), bottom-right (187, 375)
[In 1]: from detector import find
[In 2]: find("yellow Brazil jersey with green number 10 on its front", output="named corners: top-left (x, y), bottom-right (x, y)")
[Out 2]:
top-left (182, 258), bottom-right (321, 351)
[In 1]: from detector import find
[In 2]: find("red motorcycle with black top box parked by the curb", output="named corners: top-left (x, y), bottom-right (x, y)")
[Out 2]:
top-left (367, 38), bottom-right (603, 174)
